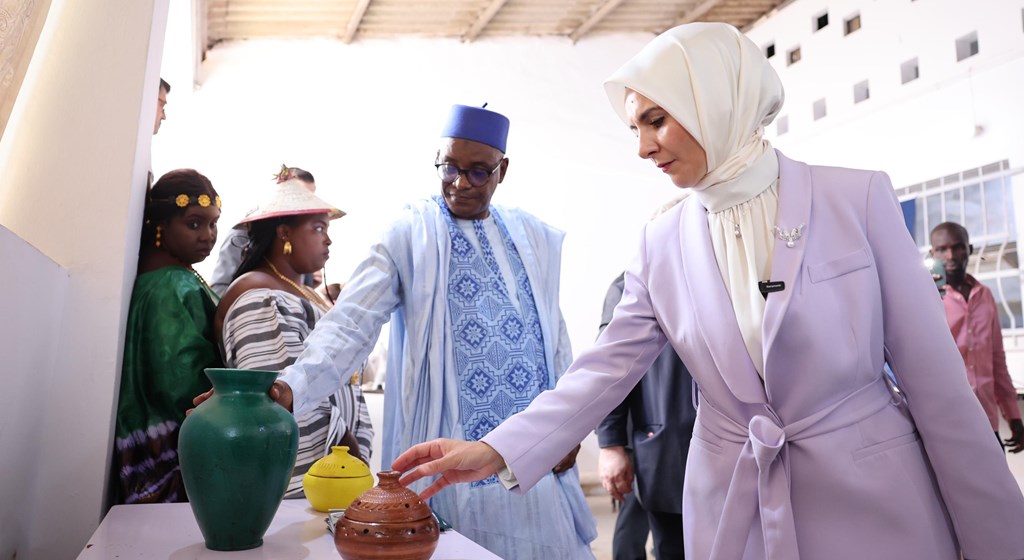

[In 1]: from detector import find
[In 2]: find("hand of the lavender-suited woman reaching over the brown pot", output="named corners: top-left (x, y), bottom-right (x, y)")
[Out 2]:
top-left (391, 439), bottom-right (505, 500)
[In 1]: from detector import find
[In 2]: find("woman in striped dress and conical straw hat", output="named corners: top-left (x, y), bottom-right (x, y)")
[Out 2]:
top-left (214, 179), bottom-right (373, 498)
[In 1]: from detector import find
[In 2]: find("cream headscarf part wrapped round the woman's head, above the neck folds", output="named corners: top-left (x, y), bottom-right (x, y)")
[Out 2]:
top-left (604, 24), bottom-right (784, 195)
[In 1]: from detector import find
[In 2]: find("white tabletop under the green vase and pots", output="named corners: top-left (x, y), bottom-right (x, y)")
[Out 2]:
top-left (78, 500), bottom-right (501, 560)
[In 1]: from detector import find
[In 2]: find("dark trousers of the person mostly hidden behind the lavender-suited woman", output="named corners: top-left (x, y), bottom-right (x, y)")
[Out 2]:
top-left (611, 492), bottom-right (684, 560)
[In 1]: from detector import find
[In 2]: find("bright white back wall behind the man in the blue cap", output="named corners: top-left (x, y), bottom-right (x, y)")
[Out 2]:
top-left (154, 35), bottom-right (676, 360)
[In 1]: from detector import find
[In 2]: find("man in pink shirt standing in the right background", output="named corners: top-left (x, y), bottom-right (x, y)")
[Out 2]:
top-left (931, 222), bottom-right (1024, 454)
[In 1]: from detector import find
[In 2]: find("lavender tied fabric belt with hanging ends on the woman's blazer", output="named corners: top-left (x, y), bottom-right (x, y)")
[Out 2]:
top-left (701, 377), bottom-right (892, 560)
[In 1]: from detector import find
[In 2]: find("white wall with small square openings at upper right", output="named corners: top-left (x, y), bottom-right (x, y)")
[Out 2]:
top-left (748, 0), bottom-right (1024, 187)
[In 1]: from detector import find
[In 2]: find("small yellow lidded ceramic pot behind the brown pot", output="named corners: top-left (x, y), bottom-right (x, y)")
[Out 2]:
top-left (302, 445), bottom-right (374, 512)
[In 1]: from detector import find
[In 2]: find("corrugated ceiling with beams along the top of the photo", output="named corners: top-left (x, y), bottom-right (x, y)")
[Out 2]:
top-left (206, 0), bottom-right (790, 44)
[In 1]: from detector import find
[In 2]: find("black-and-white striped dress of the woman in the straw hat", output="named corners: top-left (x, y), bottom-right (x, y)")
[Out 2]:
top-left (223, 288), bottom-right (374, 498)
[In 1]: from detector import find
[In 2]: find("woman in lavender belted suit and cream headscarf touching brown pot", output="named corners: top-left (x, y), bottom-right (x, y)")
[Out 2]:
top-left (394, 24), bottom-right (1024, 560)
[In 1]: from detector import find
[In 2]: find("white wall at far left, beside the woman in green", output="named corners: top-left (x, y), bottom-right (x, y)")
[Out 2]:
top-left (0, 0), bottom-right (168, 560)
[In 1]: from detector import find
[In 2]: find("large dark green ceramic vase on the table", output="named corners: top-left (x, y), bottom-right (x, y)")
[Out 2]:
top-left (178, 369), bottom-right (299, 551)
